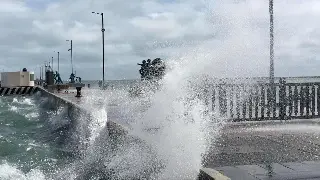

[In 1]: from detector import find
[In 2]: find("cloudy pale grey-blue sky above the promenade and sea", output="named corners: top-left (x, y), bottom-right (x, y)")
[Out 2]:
top-left (0, 0), bottom-right (320, 80)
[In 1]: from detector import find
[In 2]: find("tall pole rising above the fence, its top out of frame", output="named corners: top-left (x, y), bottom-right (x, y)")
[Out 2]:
top-left (269, 0), bottom-right (274, 84)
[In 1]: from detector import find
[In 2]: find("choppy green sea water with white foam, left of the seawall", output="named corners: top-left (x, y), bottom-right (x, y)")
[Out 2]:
top-left (0, 97), bottom-right (68, 180)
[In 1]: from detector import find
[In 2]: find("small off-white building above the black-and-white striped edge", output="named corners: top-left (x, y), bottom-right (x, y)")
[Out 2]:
top-left (1, 71), bottom-right (34, 87)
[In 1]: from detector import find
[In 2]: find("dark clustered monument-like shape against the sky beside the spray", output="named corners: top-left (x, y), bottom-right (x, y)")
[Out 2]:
top-left (138, 58), bottom-right (166, 80)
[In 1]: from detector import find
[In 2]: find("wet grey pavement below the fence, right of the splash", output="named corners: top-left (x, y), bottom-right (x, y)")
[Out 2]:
top-left (205, 120), bottom-right (320, 180)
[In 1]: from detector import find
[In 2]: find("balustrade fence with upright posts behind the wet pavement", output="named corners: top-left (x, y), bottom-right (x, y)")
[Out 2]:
top-left (207, 80), bottom-right (320, 121)
